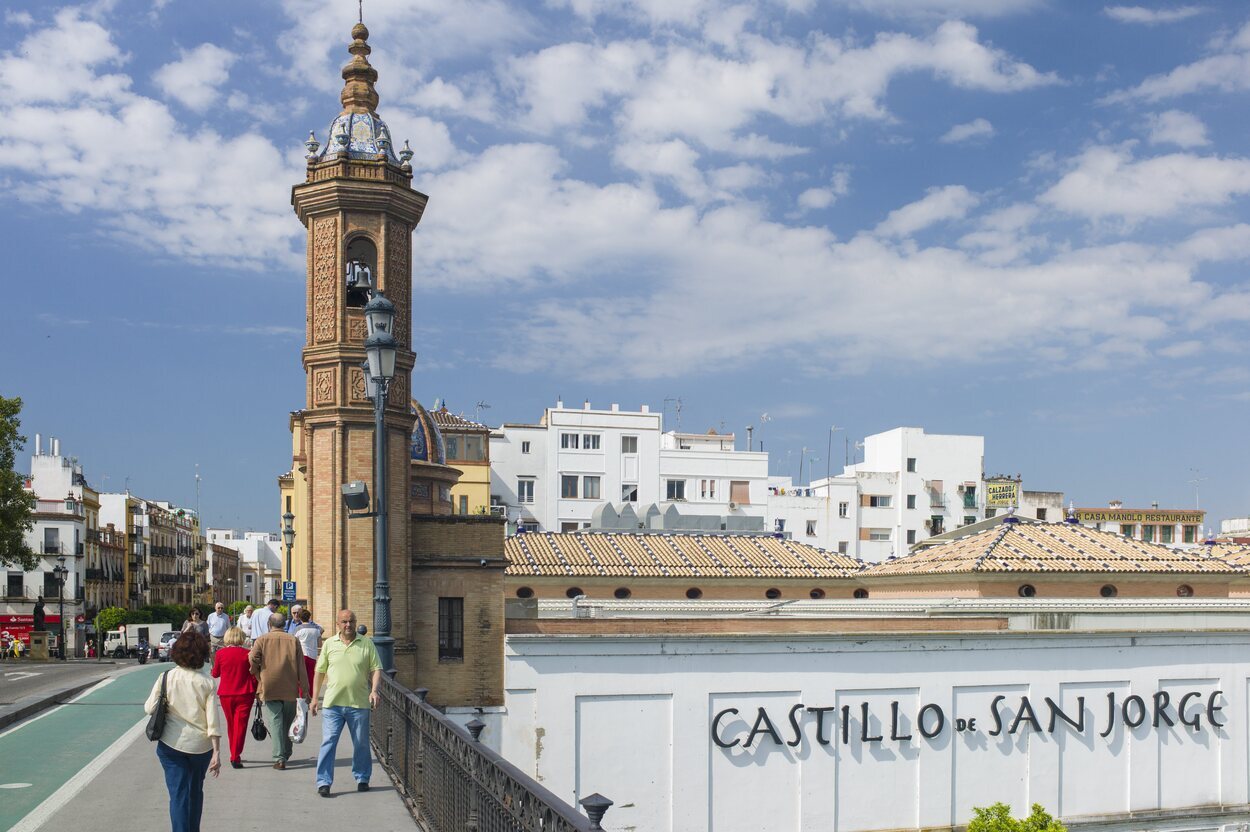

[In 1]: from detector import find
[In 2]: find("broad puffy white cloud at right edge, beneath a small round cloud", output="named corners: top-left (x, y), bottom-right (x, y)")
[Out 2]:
top-left (1040, 146), bottom-right (1250, 222)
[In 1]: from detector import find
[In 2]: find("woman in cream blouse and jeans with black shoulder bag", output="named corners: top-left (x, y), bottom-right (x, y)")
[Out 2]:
top-left (144, 630), bottom-right (221, 832)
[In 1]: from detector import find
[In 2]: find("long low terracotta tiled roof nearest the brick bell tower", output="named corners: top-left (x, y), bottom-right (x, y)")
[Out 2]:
top-left (504, 532), bottom-right (864, 578)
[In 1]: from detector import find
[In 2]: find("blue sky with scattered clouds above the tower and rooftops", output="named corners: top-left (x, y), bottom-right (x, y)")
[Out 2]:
top-left (0, 0), bottom-right (1250, 527)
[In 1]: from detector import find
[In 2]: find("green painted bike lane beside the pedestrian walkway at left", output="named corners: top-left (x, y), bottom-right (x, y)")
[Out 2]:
top-left (0, 666), bottom-right (161, 830)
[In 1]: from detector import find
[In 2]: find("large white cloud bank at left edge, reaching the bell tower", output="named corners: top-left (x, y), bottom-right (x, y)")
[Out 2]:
top-left (0, 10), bottom-right (303, 269)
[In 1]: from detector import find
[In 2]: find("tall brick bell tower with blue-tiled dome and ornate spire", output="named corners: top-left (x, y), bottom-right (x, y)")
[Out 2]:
top-left (288, 22), bottom-right (428, 680)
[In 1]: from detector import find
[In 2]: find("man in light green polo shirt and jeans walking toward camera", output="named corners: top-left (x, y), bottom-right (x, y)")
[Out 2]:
top-left (313, 610), bottom-right (383, 797)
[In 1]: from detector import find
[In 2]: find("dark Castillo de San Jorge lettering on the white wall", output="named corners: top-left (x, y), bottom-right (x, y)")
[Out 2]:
top-left (711, 691), bottom-right (1228, 748)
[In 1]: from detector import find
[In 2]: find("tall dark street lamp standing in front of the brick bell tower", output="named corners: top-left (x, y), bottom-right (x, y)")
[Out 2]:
top-left (365, 291), bottom-right (398, 676)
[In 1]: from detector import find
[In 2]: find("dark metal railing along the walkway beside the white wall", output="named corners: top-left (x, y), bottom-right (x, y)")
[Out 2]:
top-left (370, 676), bottom-right (611, 832)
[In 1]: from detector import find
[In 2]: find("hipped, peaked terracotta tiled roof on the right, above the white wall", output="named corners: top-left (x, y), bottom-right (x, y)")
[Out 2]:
top-left (864, 523), bottom-right (1239, 577)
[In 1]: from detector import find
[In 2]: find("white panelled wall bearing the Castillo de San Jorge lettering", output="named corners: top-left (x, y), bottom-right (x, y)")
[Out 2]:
top-left (500, 632), bottom-right (1250, 832)
